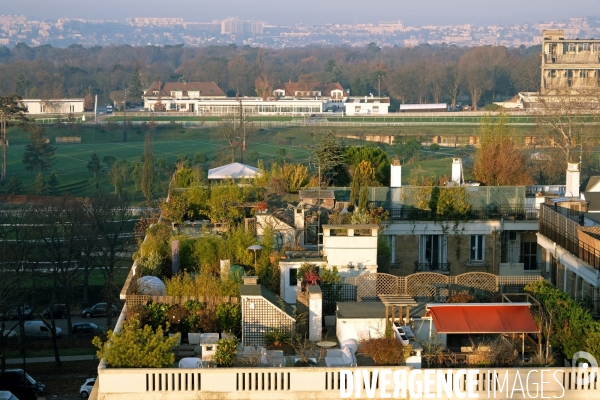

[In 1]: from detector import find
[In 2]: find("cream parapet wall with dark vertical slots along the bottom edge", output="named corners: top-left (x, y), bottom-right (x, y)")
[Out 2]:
top-left (98, 367), bottom-right (600, 400)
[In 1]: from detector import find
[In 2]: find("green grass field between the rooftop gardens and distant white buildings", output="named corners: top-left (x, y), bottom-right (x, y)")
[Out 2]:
top-left (1, 124), bottom-right (488, 197)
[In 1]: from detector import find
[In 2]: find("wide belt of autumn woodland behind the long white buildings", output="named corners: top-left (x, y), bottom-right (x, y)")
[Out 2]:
top-left (0, 43), bottom-right (540, 104)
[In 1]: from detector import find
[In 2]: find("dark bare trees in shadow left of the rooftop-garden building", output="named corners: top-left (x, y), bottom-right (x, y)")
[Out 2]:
top-left (0, 193), bottom-right (132, 364)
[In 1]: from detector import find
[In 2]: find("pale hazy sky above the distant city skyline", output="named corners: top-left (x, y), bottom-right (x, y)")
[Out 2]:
top-left (0, 0), bottom-right (600, 26)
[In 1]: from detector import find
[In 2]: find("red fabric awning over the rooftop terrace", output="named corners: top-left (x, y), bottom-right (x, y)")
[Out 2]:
top-left (427, 303), bottom-right (539, 333)
